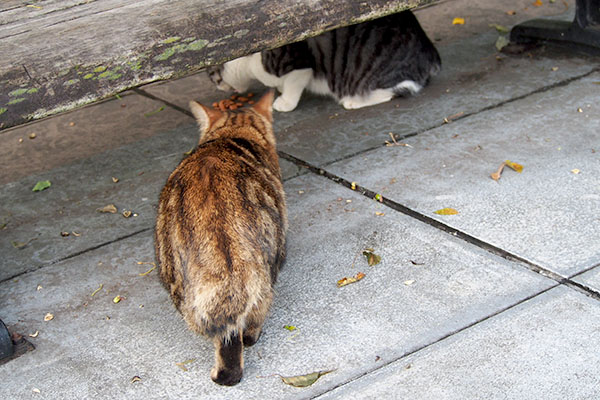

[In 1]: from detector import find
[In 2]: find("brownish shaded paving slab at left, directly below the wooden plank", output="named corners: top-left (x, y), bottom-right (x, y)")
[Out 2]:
top-left (0, 92), bottom-right (191, 184)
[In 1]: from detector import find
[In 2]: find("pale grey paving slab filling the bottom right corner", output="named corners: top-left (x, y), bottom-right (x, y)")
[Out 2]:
top-left (318, 286), bottom-right (600, 400)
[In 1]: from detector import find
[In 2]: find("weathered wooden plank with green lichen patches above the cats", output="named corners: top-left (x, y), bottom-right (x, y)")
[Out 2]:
top-left (0, 0), bottom-right (435, 129)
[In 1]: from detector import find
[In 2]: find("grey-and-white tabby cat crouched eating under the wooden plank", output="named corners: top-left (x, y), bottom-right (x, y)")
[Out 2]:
top-left (209, 11), bottom-right (441, 111)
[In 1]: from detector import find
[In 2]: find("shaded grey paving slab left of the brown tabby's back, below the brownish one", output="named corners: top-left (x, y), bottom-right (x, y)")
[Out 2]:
top-left (0, 119), bottom-right (300, 280)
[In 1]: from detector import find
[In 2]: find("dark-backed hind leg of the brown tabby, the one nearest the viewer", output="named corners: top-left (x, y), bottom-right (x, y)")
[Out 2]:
top-left (210, 333), bottom-right (244, 386)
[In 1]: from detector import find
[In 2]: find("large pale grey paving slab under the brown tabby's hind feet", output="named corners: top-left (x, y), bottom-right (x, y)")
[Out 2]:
top-left (0, 175), bottom-right (556, 399)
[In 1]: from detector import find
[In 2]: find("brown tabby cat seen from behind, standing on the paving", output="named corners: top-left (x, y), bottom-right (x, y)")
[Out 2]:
top-left (155, 91), bottom-right (287, 386)
